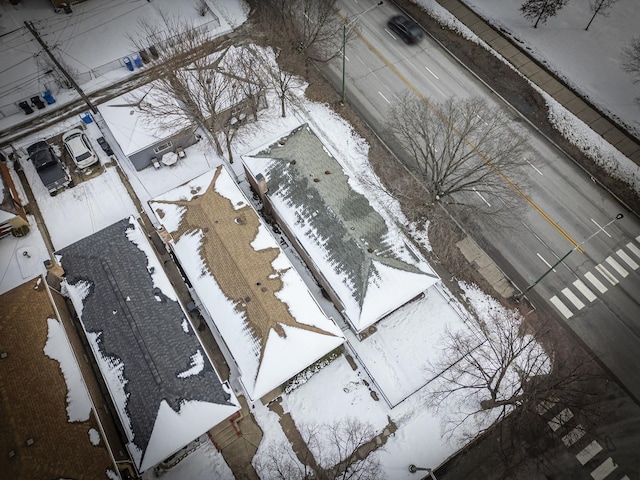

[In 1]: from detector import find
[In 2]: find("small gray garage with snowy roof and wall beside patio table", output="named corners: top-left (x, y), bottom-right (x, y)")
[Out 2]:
top-left (98, 83), bottom-right (198, 171)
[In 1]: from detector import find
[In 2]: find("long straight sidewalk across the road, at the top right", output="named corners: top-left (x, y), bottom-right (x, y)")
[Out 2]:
top-left (437, 0), bottom-right (640, 165)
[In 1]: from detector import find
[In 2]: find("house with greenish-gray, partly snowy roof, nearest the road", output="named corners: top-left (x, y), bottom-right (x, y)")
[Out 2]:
top-left (243, 124), bottom-right (438, 333)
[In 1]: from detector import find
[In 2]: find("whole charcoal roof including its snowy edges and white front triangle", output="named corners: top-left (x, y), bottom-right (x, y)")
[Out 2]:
top-left (57, 218), bottom-right (239, 472)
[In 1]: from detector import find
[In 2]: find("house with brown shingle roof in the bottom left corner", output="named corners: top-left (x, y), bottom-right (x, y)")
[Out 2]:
top-left (0, 276), bottom-right (120, 480)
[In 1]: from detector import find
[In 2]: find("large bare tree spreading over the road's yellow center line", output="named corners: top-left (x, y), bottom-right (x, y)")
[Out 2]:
top-left (387, 94), bottom-right (527, 216)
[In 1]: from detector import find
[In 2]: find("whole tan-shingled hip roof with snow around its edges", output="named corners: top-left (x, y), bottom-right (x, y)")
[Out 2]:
top-left (149, 166), bottom-right (344, 399)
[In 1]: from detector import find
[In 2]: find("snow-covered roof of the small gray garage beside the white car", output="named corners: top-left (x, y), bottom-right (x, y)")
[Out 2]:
top-left (98, 83), bottom-right (190, 156)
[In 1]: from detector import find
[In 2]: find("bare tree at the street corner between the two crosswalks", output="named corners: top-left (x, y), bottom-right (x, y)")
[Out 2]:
top-left (427, 296), bottom-right (601, 450)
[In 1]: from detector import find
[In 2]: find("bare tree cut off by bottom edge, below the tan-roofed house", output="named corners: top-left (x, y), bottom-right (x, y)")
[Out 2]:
top-left (253, 418), bottom-right (384, 480)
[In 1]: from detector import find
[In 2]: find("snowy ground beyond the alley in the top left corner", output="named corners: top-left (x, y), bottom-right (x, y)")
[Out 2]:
top-left (0, 0), bottom-right (247, 130)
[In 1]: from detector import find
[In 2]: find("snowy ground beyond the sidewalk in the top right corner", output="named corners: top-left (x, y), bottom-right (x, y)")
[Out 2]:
top-left (456, 0), bottom-right (640, 135)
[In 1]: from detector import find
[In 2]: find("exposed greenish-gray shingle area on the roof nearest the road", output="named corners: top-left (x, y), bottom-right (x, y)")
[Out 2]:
top-left (245, 125), bottom-right (436, 332)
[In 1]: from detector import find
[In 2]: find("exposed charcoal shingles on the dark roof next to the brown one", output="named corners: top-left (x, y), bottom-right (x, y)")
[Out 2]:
top-left (57, 219), bottom-right (233, 472)
